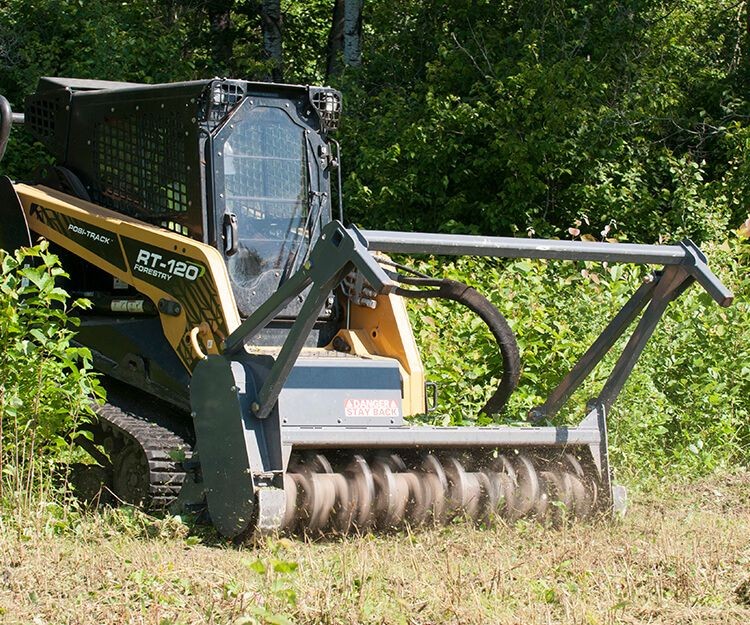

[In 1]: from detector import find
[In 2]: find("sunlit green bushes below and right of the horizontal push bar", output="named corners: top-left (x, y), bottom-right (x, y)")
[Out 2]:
top-left (410, 232), bottom-right (750, 476)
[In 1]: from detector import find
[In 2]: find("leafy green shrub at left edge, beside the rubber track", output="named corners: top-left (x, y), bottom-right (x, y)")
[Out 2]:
top-left (0, 243), bottom-right (101, 498)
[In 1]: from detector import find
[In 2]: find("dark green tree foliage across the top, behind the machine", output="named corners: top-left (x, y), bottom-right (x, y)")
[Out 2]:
top-left (0, 0), bottom-right (750, 242)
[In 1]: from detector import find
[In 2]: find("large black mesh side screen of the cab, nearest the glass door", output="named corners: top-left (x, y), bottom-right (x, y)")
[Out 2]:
top-left (94, 112), bottom-right (189, 217)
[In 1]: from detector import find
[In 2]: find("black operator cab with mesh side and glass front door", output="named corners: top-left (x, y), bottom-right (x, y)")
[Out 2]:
top-left (26, 78), bottom-right (341, 320)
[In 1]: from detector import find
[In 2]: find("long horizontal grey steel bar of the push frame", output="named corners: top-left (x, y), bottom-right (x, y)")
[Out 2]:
top-left (362, 230), bottom-right (687, 265)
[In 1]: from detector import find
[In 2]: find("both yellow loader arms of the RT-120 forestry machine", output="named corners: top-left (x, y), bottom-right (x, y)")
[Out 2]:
top-left (15, 184), bottom-right (425, 415)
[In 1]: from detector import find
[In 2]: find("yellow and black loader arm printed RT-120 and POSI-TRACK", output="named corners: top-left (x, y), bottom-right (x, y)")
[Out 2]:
top-left (15, 184), bottom-right (240, 371)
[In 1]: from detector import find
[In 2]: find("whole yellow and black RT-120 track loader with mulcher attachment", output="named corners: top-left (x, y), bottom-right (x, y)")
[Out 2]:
top-left (0, 78), bottom-right (732, 537)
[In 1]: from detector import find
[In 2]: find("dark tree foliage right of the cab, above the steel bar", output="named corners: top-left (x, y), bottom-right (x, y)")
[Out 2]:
top-left (343, 0), bottom-right (750, 241)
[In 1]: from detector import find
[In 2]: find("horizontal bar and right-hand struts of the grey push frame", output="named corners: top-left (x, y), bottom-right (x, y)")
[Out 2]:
top-left (362, 230), bottom-right (734, 423)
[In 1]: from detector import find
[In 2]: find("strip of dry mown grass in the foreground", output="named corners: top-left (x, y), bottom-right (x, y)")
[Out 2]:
top-left (0, 473), bottom-right (750, 625)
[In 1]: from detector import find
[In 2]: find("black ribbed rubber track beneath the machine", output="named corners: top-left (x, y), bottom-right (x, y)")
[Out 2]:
top-left (94, 403), bottom-right (192, 510)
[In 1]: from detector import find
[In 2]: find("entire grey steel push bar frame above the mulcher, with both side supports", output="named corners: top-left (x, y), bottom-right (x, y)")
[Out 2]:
top-left (223, 221), bottom-right (734, 444)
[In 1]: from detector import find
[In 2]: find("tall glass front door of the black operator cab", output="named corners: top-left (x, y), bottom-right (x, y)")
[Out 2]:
top-left (210, 85), bottom-right (338, 316)
